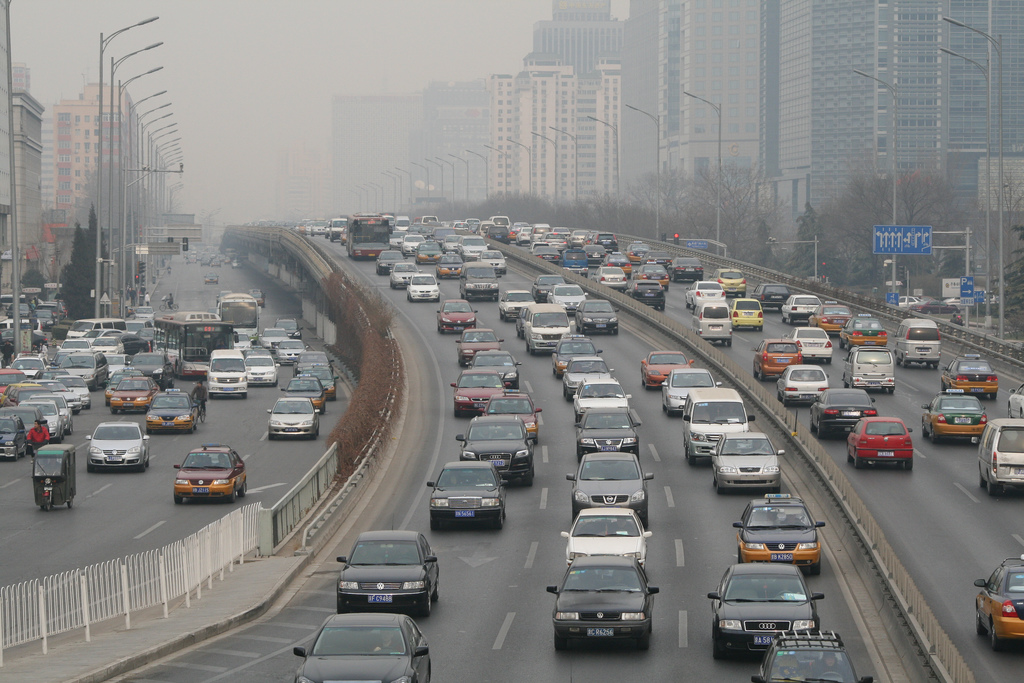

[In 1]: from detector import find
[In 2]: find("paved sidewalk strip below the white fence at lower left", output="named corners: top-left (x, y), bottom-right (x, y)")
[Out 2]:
top-left (0, 555), bottom-right (310, 683)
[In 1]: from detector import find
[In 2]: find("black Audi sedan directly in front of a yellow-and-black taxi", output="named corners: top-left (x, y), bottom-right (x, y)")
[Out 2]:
top-left (708, 564), bottom-right (824, 659)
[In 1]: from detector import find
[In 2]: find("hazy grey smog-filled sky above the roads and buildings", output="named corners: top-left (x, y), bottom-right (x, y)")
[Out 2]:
top-left (11, 0), bottom-right (628, 223)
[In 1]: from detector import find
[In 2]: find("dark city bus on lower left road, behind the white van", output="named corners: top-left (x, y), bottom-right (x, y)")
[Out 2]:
top-left (153, 311), bottom-right (234, 379)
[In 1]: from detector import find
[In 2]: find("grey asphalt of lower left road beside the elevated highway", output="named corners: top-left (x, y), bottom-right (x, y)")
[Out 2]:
top-left (0, 258), bottom-right (345, 586)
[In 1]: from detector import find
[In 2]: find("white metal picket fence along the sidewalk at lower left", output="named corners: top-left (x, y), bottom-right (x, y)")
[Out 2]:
top-left (0, 503), bottom-right (259, 667)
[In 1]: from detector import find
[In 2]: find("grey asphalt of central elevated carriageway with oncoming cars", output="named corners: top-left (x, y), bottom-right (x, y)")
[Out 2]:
top-left (112, 236), bottom-right (916, 682)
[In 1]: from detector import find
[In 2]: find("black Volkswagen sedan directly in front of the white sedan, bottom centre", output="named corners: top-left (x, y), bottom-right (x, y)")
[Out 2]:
top-left (548, 556), bottom-right (658, 650)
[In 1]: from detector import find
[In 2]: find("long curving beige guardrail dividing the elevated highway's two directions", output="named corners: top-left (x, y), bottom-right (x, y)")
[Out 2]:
top-left (490, 241), bottom-right (975, 683)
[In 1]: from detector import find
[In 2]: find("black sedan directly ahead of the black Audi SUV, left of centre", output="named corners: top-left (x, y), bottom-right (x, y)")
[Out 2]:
top-left (427, 461), bottom-right (505, 530)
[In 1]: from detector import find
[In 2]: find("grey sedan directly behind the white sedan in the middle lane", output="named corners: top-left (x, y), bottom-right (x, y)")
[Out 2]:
top-left (565, 452), bottom-right (654, 526)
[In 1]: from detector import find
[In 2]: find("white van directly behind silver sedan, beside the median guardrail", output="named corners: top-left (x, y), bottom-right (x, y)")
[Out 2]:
top-left (683, 387), bottom-right (754, 465)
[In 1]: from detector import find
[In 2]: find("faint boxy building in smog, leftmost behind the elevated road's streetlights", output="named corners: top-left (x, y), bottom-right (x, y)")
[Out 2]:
top-left (332, 94), bottom-right (419, 215)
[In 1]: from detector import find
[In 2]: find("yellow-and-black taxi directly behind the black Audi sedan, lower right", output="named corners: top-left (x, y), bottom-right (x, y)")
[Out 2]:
top-left (732, 494), bottom-right (825, 574)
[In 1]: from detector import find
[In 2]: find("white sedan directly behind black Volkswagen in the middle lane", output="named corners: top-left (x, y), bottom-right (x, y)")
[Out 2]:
top-left (562, 508), bottom-right (653, 566)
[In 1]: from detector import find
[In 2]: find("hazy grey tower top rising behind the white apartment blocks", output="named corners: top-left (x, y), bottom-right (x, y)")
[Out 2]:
top-left (534, 0), bottom-right (623, 75)
